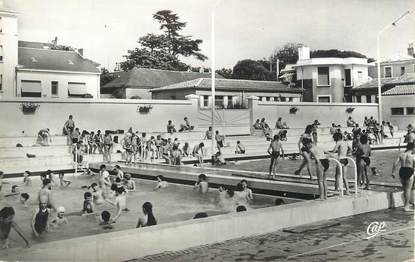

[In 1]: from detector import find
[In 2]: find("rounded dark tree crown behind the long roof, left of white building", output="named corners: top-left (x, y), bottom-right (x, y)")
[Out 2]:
top-left (232, 59), bottom-right (273, 81)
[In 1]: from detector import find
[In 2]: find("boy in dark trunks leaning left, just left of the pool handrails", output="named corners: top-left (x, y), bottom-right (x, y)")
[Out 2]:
top-left (303, 138), bottom-right (330, 200)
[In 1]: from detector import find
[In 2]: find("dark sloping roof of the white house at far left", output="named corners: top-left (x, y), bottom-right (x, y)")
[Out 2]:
top-left (18, 46), bottom-right (101, 74)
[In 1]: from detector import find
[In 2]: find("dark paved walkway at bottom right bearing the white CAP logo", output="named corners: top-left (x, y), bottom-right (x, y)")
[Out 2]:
top-left (135, 209), bottom-right (414, 262)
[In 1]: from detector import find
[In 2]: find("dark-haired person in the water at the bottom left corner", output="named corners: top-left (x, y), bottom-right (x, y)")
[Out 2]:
top-left (0, 207), bottom-right (30, 249)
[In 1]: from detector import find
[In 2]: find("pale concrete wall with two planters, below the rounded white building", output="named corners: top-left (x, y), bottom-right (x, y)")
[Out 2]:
top-left (253, 97), bottom-right (378, 128)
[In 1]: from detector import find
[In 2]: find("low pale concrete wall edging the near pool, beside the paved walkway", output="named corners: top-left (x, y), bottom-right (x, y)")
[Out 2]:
top-left (0, 192), bottom-right (402, 261)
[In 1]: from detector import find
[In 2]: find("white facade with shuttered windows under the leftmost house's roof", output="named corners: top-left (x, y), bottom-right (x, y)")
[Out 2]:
top-left (17, 71), bottom-right (100, 98)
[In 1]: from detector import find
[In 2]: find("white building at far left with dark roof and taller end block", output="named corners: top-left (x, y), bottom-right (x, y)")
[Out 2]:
top-left (0, 1), bottom-right (100, 98)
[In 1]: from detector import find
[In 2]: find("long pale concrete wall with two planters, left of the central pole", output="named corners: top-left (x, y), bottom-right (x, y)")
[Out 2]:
top-left (0, 98), bottom-right (197, 136)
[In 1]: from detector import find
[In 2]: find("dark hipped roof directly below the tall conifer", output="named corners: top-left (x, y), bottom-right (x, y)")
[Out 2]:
top-left (101, 67), bottom-right (223, 89)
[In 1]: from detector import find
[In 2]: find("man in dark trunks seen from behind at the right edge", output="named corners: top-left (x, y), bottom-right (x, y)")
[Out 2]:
top-left (392, 143), bottom-right (415, 212)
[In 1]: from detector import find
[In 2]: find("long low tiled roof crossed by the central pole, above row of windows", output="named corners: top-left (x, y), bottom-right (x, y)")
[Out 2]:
top-left (150, 78), bottom-right (303, 93)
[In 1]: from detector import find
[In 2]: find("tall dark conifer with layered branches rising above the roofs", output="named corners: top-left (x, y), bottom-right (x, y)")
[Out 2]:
top-left (120, 10), bottom-right (207, 71)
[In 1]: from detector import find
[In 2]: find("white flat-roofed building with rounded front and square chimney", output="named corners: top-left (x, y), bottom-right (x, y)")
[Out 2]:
top-left (294, 47), bottom-right (369, 103)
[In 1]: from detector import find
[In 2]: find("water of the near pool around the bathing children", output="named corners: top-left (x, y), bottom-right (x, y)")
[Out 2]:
top-left (0, 175), bottom-right (293, 247)
